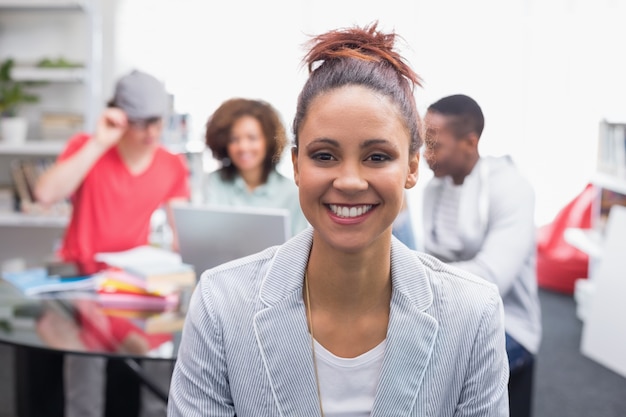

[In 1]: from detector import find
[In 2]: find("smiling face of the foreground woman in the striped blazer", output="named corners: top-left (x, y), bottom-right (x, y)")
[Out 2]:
top-left (293, 86), bottom-right (419, 252)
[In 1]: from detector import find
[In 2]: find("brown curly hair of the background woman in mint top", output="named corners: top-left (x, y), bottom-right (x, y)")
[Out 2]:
top-left (205, 98), bottom-right (287, 182)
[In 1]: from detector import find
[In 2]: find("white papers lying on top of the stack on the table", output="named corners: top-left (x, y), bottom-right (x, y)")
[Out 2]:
top-left (95, 245), bottom-right (182, 268)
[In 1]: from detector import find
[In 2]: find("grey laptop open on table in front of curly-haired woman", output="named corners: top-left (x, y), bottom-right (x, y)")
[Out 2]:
top-left (172, 204), bottom-right (291, 277)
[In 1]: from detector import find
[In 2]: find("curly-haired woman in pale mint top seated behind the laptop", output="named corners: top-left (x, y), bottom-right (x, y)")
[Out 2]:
top-left (203, 98), bottom-right (308, 235)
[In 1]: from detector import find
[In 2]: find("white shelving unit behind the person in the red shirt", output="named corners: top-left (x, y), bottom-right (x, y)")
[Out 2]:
top-left (0, 0), bottom-right (104, 224)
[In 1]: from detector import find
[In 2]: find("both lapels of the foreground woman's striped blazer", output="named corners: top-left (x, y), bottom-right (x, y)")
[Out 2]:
top-left (254, 227), bottom-right (438, 416)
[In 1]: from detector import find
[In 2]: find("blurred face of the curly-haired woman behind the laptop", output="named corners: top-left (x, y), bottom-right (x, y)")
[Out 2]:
top-left (226, 116), bottom-right (267, 172)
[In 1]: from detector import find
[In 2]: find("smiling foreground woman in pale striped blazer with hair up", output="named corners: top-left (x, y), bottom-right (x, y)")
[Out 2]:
top-left (168, 24), bottom-right (508, 417)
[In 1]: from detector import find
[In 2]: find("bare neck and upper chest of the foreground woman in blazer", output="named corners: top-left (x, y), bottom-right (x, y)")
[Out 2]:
top-left (303, 232), bottom-right (392, 358)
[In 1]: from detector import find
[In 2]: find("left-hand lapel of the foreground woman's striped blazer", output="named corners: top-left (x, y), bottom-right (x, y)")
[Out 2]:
top-left (254, 229), bottom-right (320, 417)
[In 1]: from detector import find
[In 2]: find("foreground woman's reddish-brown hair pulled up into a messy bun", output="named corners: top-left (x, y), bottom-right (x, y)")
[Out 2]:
top-left (292, 22), bottom-right (422, 154)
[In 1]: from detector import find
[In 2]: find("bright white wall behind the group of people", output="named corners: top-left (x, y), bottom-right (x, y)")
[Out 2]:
top-left (109, 0), bottom-right (626, 231)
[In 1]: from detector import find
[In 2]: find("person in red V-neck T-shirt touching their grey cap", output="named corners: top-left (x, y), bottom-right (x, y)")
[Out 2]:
top-left (35, 70), bottom-right (190, 417)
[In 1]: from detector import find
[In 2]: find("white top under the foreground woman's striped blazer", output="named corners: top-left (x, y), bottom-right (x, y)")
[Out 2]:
top-left (315, 340), bottom-right (385, 417)
